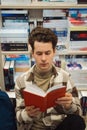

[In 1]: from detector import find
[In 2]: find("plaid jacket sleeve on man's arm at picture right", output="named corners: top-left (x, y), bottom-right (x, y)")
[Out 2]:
top-left (56, 69), bottom-right (82, 115)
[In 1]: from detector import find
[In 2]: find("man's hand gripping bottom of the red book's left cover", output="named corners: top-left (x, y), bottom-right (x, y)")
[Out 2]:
top-left (25, 106), bottom-right (40, 117)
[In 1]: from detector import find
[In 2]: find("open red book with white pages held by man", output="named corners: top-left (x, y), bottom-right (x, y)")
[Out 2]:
top-left (23, 85), bottom-right (66, 111)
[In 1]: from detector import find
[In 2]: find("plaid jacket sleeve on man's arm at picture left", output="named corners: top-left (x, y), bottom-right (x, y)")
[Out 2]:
top-left (15, 77), bottom-right (32, 123)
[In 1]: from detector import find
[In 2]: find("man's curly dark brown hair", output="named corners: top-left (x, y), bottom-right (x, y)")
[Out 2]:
top-left (29, 27), bottom-right (58, 51)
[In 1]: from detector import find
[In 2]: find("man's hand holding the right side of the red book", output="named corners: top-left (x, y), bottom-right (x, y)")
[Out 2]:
top-left (56, 93), bottom-right (73, 110)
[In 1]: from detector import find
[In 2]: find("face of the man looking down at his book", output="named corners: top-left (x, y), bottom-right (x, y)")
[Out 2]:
top-left (33, 41), bottom-right (55, 72)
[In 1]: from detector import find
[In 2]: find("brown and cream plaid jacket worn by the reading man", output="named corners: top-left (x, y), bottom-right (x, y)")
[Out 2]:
top-left (15, 65), bottom-right (82, 130)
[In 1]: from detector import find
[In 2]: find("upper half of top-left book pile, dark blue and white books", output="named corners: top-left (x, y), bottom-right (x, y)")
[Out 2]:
top-left (1, 10), bottom-right (29, 29)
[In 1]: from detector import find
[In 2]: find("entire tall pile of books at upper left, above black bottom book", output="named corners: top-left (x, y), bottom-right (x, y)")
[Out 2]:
top-left (0, 10), bottom-right (29, 51)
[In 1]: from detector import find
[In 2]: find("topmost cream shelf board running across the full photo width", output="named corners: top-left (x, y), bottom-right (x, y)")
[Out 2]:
top-left (0, 2), bottom-right (87, 9)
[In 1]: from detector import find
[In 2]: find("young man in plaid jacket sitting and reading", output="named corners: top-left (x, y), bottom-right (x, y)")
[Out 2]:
top-left (15, 27), bottom-right (85, 130)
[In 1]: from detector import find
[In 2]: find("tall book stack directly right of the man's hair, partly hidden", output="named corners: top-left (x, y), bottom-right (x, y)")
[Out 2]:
top-left (43, 9), bottom-right (68, 51)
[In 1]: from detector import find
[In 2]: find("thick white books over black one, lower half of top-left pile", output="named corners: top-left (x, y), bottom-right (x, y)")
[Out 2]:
top-left (0, 28), bottom-right (28, 51)
